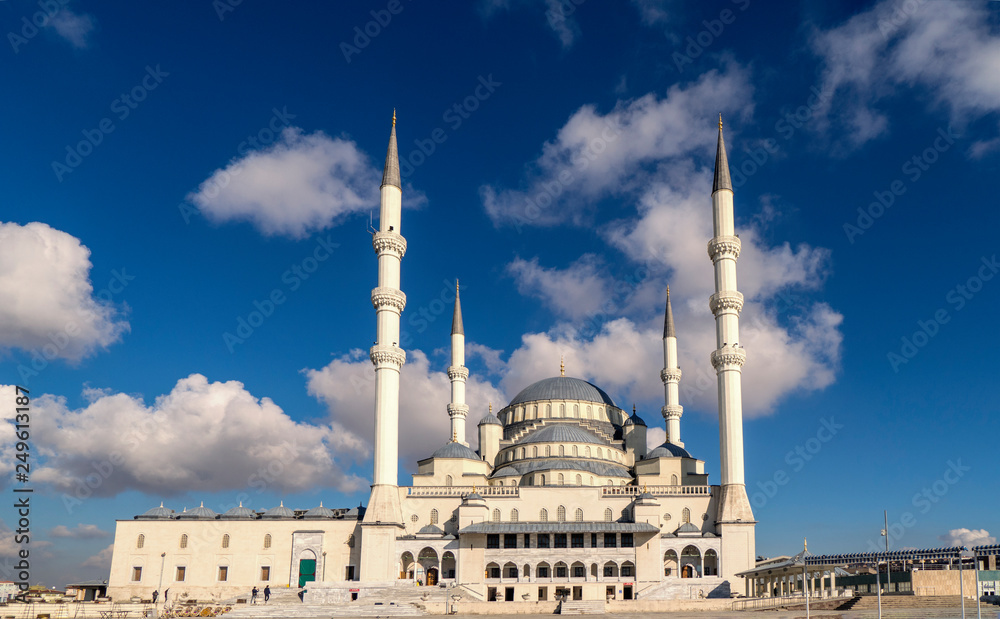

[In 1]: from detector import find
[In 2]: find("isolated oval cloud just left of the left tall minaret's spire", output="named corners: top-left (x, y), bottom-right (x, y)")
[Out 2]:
top-left (188, 127), bottom-right (381, 238)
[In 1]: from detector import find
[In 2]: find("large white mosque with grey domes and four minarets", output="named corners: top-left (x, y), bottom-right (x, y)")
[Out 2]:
top-left (108, 117), bottom-right (756, 603)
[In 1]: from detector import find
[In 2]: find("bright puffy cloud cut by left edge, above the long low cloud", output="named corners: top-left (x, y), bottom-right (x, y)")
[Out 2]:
top-left (0, 222), bottom-right (131, 363)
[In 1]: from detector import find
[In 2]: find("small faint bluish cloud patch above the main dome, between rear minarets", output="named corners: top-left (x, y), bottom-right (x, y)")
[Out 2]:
top-left (506, 254), bottom-right (610, 319)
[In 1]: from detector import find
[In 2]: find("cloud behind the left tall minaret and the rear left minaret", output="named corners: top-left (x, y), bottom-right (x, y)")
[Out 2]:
top-left (306, 350), bottom-right (506, 465)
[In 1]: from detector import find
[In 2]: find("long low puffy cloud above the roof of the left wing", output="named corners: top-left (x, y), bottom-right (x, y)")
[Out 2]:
top-left (32, 374), bottom-right (367, 498)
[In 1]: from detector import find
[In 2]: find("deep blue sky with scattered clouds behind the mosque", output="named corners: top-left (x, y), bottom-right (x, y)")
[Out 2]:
top-left (0, 0), bottom-right (1000, 586)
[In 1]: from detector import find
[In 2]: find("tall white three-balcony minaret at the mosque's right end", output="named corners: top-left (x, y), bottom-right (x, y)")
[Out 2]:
top-left (708, 115), bottom-right (755, 580)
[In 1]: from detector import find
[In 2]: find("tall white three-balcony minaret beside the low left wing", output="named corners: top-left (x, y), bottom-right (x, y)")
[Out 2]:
top-left (361, 111), bottom-right (406, 581)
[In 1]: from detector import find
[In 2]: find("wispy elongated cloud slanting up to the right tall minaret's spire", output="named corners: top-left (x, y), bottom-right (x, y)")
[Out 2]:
top-left (480, 63), bottom-right (753, 227)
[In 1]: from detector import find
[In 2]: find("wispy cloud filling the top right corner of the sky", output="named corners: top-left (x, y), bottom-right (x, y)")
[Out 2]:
top-left (810, 0), bottom-right (1000, 149)
